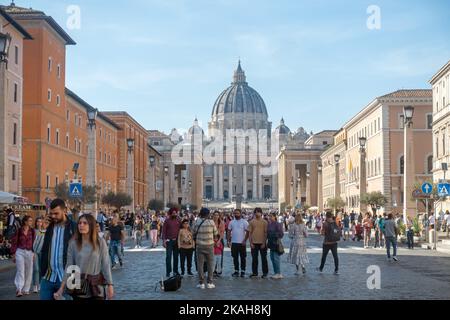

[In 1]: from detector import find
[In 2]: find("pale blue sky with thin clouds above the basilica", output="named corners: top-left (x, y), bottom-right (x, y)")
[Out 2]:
top-left (12, 0), bottom-right (450, 132)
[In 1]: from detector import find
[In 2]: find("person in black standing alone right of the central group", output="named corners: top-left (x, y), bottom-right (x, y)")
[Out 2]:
top-left (317, 212), bottom-right (342, 275)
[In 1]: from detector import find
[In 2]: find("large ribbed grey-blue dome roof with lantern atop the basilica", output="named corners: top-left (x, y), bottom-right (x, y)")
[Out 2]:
top-left (212, 61), bottom-right (268, 116)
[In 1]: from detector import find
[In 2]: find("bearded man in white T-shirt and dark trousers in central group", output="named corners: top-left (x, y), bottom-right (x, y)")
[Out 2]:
top-left (227, 209), bottom-right (249, 277)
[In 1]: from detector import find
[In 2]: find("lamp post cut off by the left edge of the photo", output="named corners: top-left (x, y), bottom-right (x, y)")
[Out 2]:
top-left (0, 32), bottom-right (11, 191)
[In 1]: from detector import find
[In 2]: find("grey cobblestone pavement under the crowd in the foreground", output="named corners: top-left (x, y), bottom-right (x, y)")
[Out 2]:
top-left (0, 233), bottom-right (450, 300)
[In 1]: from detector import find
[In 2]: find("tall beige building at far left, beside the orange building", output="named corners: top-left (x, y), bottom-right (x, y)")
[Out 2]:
top-left (0, 9), bottom-right (32, 195)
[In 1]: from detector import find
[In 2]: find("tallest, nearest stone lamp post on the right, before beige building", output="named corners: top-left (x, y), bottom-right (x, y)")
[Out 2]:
top-left (403, 106), bottom-right (415, 223)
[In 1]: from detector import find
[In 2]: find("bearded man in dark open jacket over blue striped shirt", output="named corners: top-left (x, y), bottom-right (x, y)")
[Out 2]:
top-left (40, 199), bottom-right (77, 300)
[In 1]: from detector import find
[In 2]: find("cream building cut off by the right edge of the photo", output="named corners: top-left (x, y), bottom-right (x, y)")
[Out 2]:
top-left (430, 61), bottom-right (450, 211)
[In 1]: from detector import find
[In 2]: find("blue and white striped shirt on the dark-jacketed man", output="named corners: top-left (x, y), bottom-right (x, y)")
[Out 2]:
top-left (45, 226), bottom-right (65, 283)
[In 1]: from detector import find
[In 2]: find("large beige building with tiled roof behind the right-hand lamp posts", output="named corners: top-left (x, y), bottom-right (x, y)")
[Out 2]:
top-left (322, 90), bottom-right (432, 213)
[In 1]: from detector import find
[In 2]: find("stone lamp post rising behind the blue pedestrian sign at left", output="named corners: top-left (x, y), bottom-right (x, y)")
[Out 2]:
top-left (86, 109), bottom-right (98, 217)
